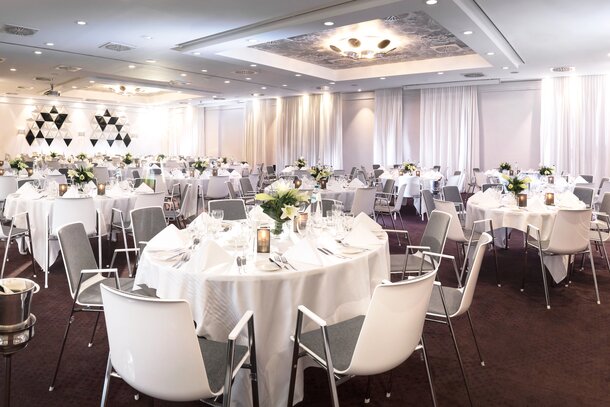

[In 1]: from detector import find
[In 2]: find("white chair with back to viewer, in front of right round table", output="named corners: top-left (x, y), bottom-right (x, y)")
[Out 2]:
top-left (521, 209), bottom-right (600, 309)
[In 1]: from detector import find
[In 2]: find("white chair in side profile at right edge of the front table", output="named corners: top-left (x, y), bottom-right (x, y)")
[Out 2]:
top-left (424, 233), bottom-right (492, 405)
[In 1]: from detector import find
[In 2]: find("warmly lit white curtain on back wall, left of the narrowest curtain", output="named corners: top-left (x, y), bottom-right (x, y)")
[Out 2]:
top-left (276, 93), bottom-right (343, 168)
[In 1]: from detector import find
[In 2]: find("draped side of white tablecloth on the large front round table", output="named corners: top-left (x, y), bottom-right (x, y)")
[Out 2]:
top-left (135, 228), bottom-right (390, 407)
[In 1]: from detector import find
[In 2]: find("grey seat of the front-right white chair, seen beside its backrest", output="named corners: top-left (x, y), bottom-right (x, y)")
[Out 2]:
top-left (301, 315), bottom-right (364, 371)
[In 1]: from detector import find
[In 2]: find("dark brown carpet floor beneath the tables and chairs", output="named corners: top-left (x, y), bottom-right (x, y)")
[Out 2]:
top-left (0, 199), bottom-right (610, 407)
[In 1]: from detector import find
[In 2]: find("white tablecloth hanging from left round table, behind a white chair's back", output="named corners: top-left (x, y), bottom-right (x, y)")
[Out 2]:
top-left (4, 192), bottom-right (136, 267)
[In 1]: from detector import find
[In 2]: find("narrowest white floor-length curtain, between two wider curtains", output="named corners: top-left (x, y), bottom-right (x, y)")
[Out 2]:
top-left (373, 88), bottom-right (403, 165)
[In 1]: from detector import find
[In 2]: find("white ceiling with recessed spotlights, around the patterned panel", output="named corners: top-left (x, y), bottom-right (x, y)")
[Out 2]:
top-left (0, 0), bottom-right (610, 104)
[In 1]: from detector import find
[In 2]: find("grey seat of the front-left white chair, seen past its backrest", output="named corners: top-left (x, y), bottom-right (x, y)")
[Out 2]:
top-left (198, 337), bottom-right (248, 393)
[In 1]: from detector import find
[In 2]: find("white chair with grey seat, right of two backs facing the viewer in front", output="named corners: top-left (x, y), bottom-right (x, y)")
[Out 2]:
top-left (286, 272), bottom-right (436, 407)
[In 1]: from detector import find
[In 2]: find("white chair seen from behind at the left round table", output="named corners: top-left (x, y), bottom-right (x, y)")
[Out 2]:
top-left (44, 197), bottom-right (102, 288)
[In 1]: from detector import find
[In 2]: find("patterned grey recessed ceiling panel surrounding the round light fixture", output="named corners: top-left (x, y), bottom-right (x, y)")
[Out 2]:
top-left (250, 11), bottom-right (474, 69)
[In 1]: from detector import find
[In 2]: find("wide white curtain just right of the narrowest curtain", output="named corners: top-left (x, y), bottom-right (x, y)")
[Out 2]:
top-left (419, 86), bottom-right (479, 175)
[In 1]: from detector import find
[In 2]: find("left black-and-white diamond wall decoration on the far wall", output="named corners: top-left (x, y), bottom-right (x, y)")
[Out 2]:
top-left (25, 105), bottom-right (72, 146)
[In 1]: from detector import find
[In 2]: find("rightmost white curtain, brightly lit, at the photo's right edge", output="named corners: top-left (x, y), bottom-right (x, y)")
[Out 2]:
top-left (540, 76), bottom-right (610, 180)
